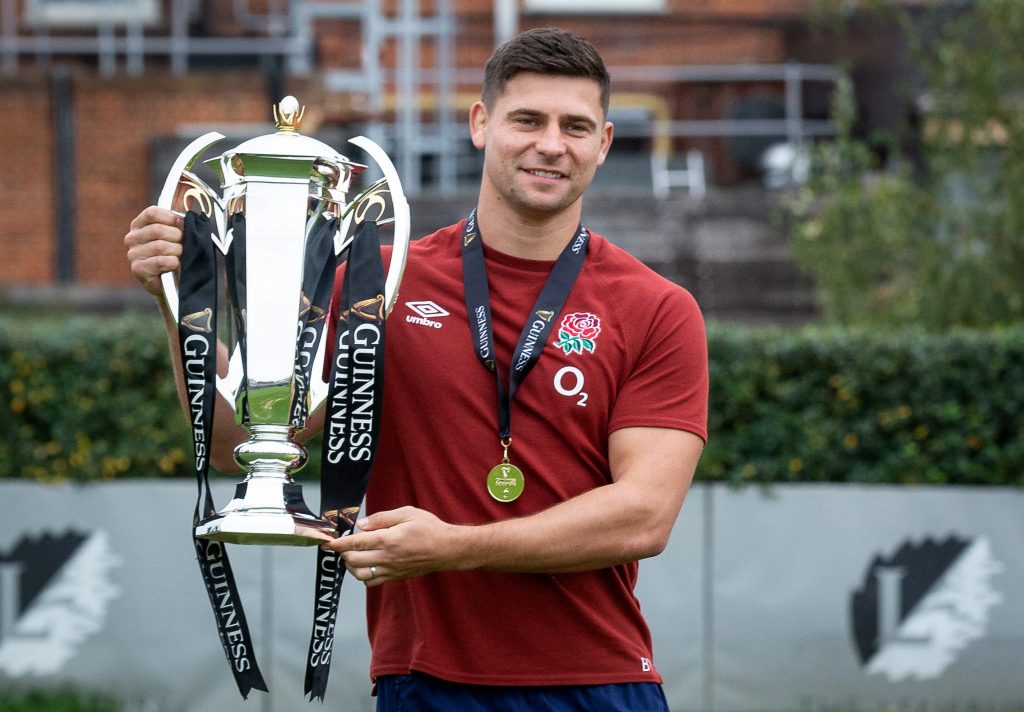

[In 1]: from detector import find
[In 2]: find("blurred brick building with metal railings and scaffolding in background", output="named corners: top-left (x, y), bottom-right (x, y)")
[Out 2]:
top-left (0, 0), bottom-right (913, 289)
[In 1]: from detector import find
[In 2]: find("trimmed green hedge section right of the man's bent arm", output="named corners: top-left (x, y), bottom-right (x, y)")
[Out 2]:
top-left (700, 329), bottom-right (1024, 486)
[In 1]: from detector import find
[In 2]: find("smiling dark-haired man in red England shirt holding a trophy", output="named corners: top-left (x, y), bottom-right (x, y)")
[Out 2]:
top-left (125, 29), bottom-right (708, 711)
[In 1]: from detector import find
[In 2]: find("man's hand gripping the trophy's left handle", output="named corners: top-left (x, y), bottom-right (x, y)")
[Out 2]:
top-left (125, 205), bottom-right (184, 296)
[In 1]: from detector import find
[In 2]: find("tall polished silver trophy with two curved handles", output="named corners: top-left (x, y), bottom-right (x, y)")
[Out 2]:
top-left (159, 96), bottom-right (410, 546)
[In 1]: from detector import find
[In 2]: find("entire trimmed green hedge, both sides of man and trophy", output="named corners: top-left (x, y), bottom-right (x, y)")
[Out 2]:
top-left (0, 316), bottom-right (1024, 486)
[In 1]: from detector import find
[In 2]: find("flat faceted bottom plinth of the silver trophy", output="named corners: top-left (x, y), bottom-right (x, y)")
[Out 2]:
top-left (196, 510), bottom-right (337, 546)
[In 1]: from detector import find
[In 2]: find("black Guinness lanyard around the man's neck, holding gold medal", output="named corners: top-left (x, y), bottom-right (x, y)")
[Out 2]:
top-left (462, 210), bottom-right (590, 452)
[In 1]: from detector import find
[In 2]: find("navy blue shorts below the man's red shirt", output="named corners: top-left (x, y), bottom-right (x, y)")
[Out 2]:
top-left (377, 673), bottom-right (669, 712)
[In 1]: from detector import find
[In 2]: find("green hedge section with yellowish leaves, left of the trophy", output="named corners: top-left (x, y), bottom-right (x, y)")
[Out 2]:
top-left (0, 316), bottom-right (191, 481)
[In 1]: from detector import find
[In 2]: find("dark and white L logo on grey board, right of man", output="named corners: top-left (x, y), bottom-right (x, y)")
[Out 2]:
top-left (851, 536), bottom-right (1005, 682)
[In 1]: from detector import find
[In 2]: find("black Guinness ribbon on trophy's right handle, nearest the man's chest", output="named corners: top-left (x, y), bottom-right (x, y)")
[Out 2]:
top-left (304, 221), bottom-right (385, 702)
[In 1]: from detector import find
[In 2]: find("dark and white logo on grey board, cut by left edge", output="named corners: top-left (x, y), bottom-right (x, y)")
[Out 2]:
top-left (0, 531), bottom-right (122, 677)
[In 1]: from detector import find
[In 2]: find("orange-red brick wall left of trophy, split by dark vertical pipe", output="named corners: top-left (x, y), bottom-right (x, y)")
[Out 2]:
top-left (0, 70), bottom-right (325, 286)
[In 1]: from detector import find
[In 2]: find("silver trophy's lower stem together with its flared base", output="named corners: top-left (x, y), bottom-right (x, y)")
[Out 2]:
top-left (196, 424), bottom-right (336, 546)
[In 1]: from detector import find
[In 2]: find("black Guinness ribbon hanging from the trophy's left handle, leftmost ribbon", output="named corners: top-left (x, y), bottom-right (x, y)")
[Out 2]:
top-left (178, 211), bottom-right (267, 698)
